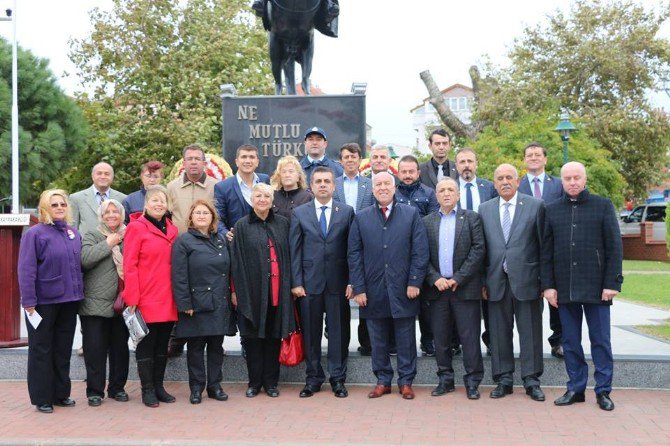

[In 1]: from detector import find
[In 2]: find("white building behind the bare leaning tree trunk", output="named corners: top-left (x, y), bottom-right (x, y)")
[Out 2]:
top-left (409, 84), bottom-right (475, 153)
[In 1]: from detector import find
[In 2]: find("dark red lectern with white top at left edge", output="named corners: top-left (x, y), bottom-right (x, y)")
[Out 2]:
top-left (0, 214), bottom-right (30, 348)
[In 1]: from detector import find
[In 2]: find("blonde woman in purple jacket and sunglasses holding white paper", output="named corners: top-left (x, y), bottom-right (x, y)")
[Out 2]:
top-left (18, 189), bottom-right (84, 413)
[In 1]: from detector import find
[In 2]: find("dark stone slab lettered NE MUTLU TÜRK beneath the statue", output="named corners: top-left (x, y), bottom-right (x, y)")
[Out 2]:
top-left (222, 95), bottom-right (365, 174)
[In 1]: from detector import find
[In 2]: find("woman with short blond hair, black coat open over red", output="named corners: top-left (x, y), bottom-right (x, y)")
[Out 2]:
top-left (233, 183), bottom-right (295, 398)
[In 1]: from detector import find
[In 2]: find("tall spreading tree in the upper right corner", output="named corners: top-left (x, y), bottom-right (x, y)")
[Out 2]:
top-left (475, 0), bottom-right (670, 198)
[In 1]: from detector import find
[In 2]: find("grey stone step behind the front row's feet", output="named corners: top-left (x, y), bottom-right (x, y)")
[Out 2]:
top-left (0, 349), bottom-right (670, 389)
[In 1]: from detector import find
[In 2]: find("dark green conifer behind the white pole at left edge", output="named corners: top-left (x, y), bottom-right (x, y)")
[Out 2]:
top-left (0, 39), bottom-right (87, 206)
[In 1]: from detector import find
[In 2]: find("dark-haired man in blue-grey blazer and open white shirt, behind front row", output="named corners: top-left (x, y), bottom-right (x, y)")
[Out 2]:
top-left (333, 142), bottom-right (374, 212)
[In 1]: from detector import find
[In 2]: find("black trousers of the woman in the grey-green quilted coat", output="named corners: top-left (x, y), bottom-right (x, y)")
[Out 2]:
top-left (79, 316), bottom-right (129, 397)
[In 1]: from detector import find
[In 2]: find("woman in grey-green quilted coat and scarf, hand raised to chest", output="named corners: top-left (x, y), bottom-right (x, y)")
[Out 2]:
top-left (79, 199), bottom-right (129, 407)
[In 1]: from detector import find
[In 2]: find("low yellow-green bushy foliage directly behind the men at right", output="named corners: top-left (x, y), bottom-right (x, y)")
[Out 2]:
top-left (469, 110), bottom-right (625, 206)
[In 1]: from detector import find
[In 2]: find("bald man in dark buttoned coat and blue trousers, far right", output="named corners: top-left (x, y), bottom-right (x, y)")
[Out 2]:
top-left (542, 162), bottom-right (623, 410)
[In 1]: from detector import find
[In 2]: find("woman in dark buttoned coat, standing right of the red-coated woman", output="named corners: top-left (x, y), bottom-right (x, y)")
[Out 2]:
top-left (172, 200), bottom-right (234, 404)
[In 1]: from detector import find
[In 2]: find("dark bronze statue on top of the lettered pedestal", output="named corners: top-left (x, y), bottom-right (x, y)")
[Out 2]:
top-left (252, 0), bottom-right (340, 95)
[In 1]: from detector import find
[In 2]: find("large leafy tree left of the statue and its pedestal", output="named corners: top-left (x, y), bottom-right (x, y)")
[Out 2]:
top-left (64, 0), bottom-right (273, 191)
